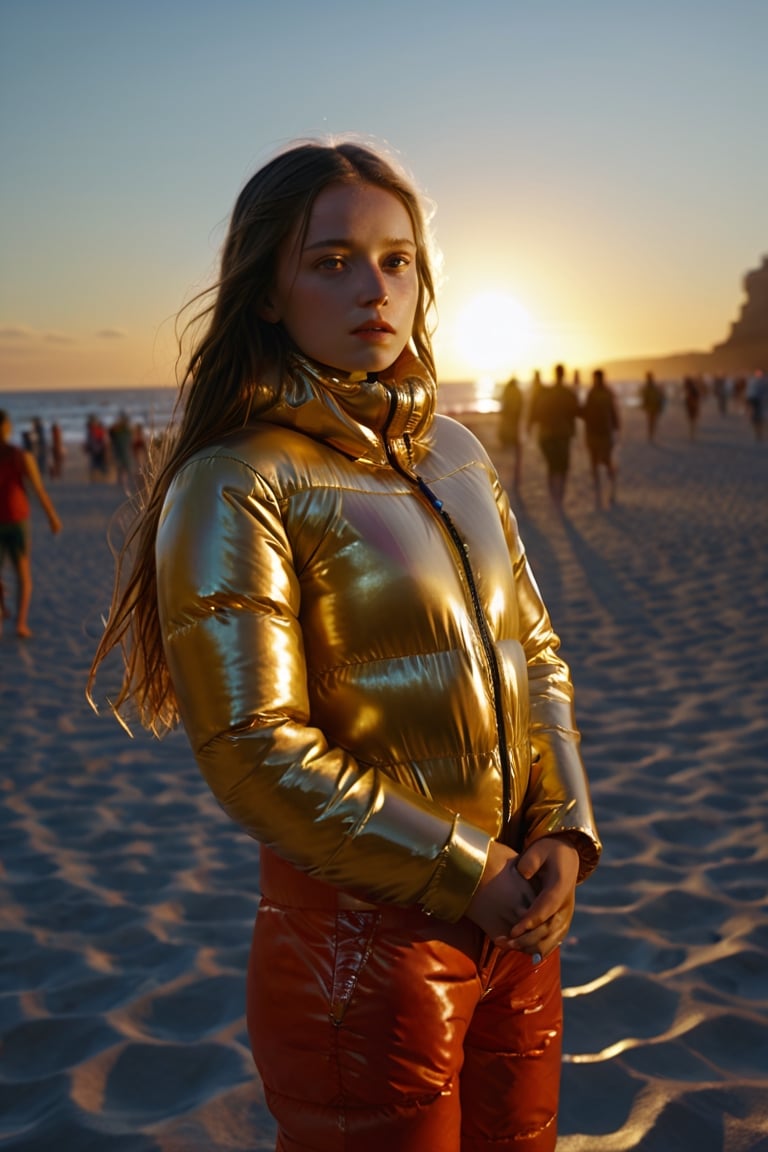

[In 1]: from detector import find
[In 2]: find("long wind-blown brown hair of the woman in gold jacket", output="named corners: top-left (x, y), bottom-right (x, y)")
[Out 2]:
top-left (86, 134), bottom-right (435, 735)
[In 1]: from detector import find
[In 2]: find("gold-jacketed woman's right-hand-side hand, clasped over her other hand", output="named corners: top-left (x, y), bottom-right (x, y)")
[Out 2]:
top-left (493, 836), bottom-right (579, 958)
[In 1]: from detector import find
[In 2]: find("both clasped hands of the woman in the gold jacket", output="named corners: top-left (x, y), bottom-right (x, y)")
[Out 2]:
top-left (466, 836), bottom-right (579, 956)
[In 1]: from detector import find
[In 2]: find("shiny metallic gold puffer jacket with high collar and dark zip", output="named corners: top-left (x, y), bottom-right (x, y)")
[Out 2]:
top-left (157, 357), bottom-right (600, 920)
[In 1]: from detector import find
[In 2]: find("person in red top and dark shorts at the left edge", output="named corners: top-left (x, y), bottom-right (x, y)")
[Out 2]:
top-left (0, 410), bottom-right (61, 637)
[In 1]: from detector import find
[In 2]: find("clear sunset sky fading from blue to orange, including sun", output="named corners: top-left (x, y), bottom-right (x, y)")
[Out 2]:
top-left (0, 0), bottom-right (768, 388)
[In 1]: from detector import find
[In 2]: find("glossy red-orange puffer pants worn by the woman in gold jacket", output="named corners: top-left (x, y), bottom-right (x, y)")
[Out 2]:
top-left (248, 849), bottom-right (562, 1152)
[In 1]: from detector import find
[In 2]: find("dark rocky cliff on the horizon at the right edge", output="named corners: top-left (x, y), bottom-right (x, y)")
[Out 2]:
top-left (604, 256), bottom-right (768, 380)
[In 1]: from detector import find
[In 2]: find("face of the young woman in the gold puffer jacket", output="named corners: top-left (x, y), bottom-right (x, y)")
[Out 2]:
top-left (263, 184), bottom-right (419, 372)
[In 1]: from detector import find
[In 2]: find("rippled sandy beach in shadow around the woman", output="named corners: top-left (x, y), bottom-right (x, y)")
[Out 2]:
top-left (0, 401), bottom-right (768, 1152)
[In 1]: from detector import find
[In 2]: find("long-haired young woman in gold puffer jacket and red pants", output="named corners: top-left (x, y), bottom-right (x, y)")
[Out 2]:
top-left (94, 143), bottom-right (600, 1152)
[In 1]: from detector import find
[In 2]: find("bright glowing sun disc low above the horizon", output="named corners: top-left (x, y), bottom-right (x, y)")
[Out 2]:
top-left (456, 291), bottom-right (533, 380)
